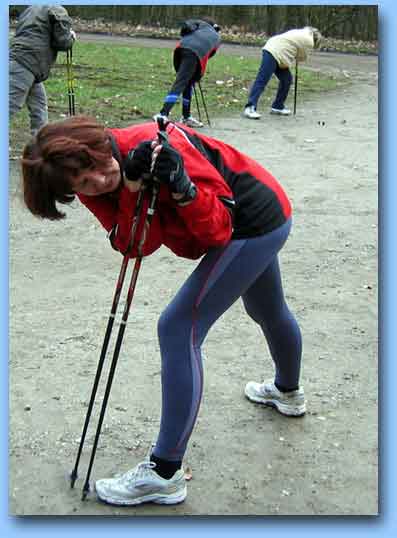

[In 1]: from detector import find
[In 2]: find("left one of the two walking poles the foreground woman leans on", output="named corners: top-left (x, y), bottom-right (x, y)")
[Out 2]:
top-left (70, 186), bottom-right (144, 488)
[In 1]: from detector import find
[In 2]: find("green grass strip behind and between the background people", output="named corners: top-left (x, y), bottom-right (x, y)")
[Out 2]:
top-left (9, 41), bottom-right (346, 156)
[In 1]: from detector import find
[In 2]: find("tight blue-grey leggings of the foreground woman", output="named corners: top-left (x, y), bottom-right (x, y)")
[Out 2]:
top-left (153, 216), bottom-right (302, 461)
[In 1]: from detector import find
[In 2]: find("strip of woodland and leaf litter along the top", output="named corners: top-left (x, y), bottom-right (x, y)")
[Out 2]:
top-left (9, 4), bottom-right (378, 53)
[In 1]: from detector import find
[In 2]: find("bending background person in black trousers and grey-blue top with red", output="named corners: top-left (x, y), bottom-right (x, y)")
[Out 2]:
top-left (153, 19), bottom-right (221, 127)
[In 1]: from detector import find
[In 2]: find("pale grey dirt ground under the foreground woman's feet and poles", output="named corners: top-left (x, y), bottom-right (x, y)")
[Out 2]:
top-left (9, 40), bottom-right (378, 510)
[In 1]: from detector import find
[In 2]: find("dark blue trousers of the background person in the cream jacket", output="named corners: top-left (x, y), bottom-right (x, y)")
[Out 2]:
top-left (246, 50), bottom-right (292, 109)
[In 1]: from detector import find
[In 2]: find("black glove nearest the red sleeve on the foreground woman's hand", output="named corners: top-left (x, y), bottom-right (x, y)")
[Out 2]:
top-left (153, 143), bottom-right (192, 194)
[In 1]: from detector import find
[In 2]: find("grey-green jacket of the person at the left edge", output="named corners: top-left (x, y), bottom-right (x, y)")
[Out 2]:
top-left (10, 5), bottom-right (74, 82)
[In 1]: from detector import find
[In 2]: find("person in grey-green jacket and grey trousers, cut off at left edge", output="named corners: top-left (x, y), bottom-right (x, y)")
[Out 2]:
top-left (9, 5), bottom-right (76, 135)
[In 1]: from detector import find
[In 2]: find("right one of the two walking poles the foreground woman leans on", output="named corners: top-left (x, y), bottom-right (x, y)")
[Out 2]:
top-left (82, 119), bottom-right (167, 501)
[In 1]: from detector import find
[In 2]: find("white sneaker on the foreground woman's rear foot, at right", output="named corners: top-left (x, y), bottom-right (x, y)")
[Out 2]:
top-left (245, 381), bottom-right (306, 417)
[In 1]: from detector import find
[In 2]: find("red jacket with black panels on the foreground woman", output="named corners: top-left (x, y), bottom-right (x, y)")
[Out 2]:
top-left (79, 122), bottom-right (291, 259)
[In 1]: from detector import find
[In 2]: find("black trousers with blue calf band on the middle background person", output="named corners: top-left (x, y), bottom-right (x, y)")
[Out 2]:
top-left (161, 49), bottom-right (200, 118)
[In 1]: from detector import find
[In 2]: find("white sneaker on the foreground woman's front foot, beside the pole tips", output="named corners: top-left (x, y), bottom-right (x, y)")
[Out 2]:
top-left (95, 461), bottom-right (187, 506)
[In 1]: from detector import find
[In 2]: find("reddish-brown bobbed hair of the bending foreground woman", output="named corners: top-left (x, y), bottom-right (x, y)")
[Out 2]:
top-left (22, 116), bottom-right (112, 220)
